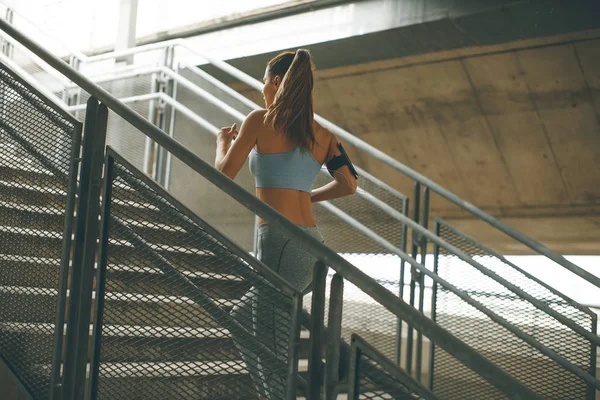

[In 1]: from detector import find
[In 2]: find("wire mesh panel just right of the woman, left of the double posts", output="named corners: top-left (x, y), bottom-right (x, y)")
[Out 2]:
top-left (304, 173), bottom-right (407, 366)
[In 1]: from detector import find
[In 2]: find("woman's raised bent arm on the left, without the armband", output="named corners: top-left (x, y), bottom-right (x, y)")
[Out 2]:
top-left (215, 110), bottom-right (264, 179)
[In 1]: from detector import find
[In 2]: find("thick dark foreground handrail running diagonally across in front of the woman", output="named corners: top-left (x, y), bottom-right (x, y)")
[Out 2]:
top-left (0, 20), bottom-right (552, 399)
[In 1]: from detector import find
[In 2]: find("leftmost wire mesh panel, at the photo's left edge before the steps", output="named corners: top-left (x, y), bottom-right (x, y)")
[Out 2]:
top-left (0, 61), bottom-right (81, 399)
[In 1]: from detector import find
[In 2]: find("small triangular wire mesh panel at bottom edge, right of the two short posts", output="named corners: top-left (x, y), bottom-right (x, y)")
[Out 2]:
top-left (349, 335), bottom-right (437, 400)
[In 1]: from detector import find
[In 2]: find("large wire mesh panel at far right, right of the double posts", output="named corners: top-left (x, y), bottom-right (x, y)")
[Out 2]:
top-left (433, 220), bottom-right (595, 399)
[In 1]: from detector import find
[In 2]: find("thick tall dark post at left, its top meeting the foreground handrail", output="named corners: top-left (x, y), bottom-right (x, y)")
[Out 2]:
top-left (63, 97), bottom-right (108, 400)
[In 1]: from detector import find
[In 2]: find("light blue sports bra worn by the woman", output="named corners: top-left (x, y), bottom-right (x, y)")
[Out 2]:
top-left (249, 147), bottom-right (321, 193)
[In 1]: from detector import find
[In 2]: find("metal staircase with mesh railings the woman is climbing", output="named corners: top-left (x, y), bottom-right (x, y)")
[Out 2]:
top-left (0, 12), bottom-right (600, 399)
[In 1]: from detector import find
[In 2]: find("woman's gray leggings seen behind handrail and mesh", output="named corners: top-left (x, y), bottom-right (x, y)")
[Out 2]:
top-left (232, 224), bottom-right (323, 400)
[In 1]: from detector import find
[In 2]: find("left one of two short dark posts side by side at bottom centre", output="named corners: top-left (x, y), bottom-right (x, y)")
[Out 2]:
top-left (306, 261), bottom-right (327, 400)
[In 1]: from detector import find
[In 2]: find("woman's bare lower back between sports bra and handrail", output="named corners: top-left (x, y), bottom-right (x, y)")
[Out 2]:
top-left (256, 188), bottom-right (316, 226)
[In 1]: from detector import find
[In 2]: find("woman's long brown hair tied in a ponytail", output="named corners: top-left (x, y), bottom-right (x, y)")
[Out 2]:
top-left (265, 49), bottom-right (315, 150)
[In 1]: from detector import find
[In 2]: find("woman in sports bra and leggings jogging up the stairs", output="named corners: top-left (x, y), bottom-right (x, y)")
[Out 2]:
top-left (215, 49), bottom-right (358, 400)
